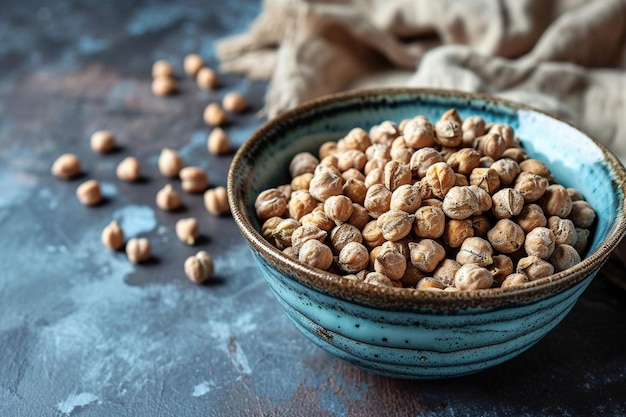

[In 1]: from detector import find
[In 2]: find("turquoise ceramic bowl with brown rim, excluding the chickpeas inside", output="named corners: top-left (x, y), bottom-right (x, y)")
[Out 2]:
top-left (228, 89), bottom-right (626, 379)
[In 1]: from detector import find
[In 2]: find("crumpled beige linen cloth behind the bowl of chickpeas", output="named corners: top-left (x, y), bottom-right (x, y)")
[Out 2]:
top-left (216, 0), bottom-right (626, 161)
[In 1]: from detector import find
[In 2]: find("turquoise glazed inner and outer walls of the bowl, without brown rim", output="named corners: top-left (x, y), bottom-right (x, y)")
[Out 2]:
top-left (230, 92), bottom-right (624, 379)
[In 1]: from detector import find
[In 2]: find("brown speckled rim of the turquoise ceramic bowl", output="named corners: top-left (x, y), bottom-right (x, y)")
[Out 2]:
top-left (227, 88), bottom-right (626, 313)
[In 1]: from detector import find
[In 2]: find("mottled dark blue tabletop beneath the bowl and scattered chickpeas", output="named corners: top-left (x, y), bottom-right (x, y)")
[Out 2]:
top-left (0, 0), bottom-right (626, 417)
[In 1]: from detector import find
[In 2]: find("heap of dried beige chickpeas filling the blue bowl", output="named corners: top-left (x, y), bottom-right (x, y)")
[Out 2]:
top-left (255, 109), bottom-right (596, 291)
